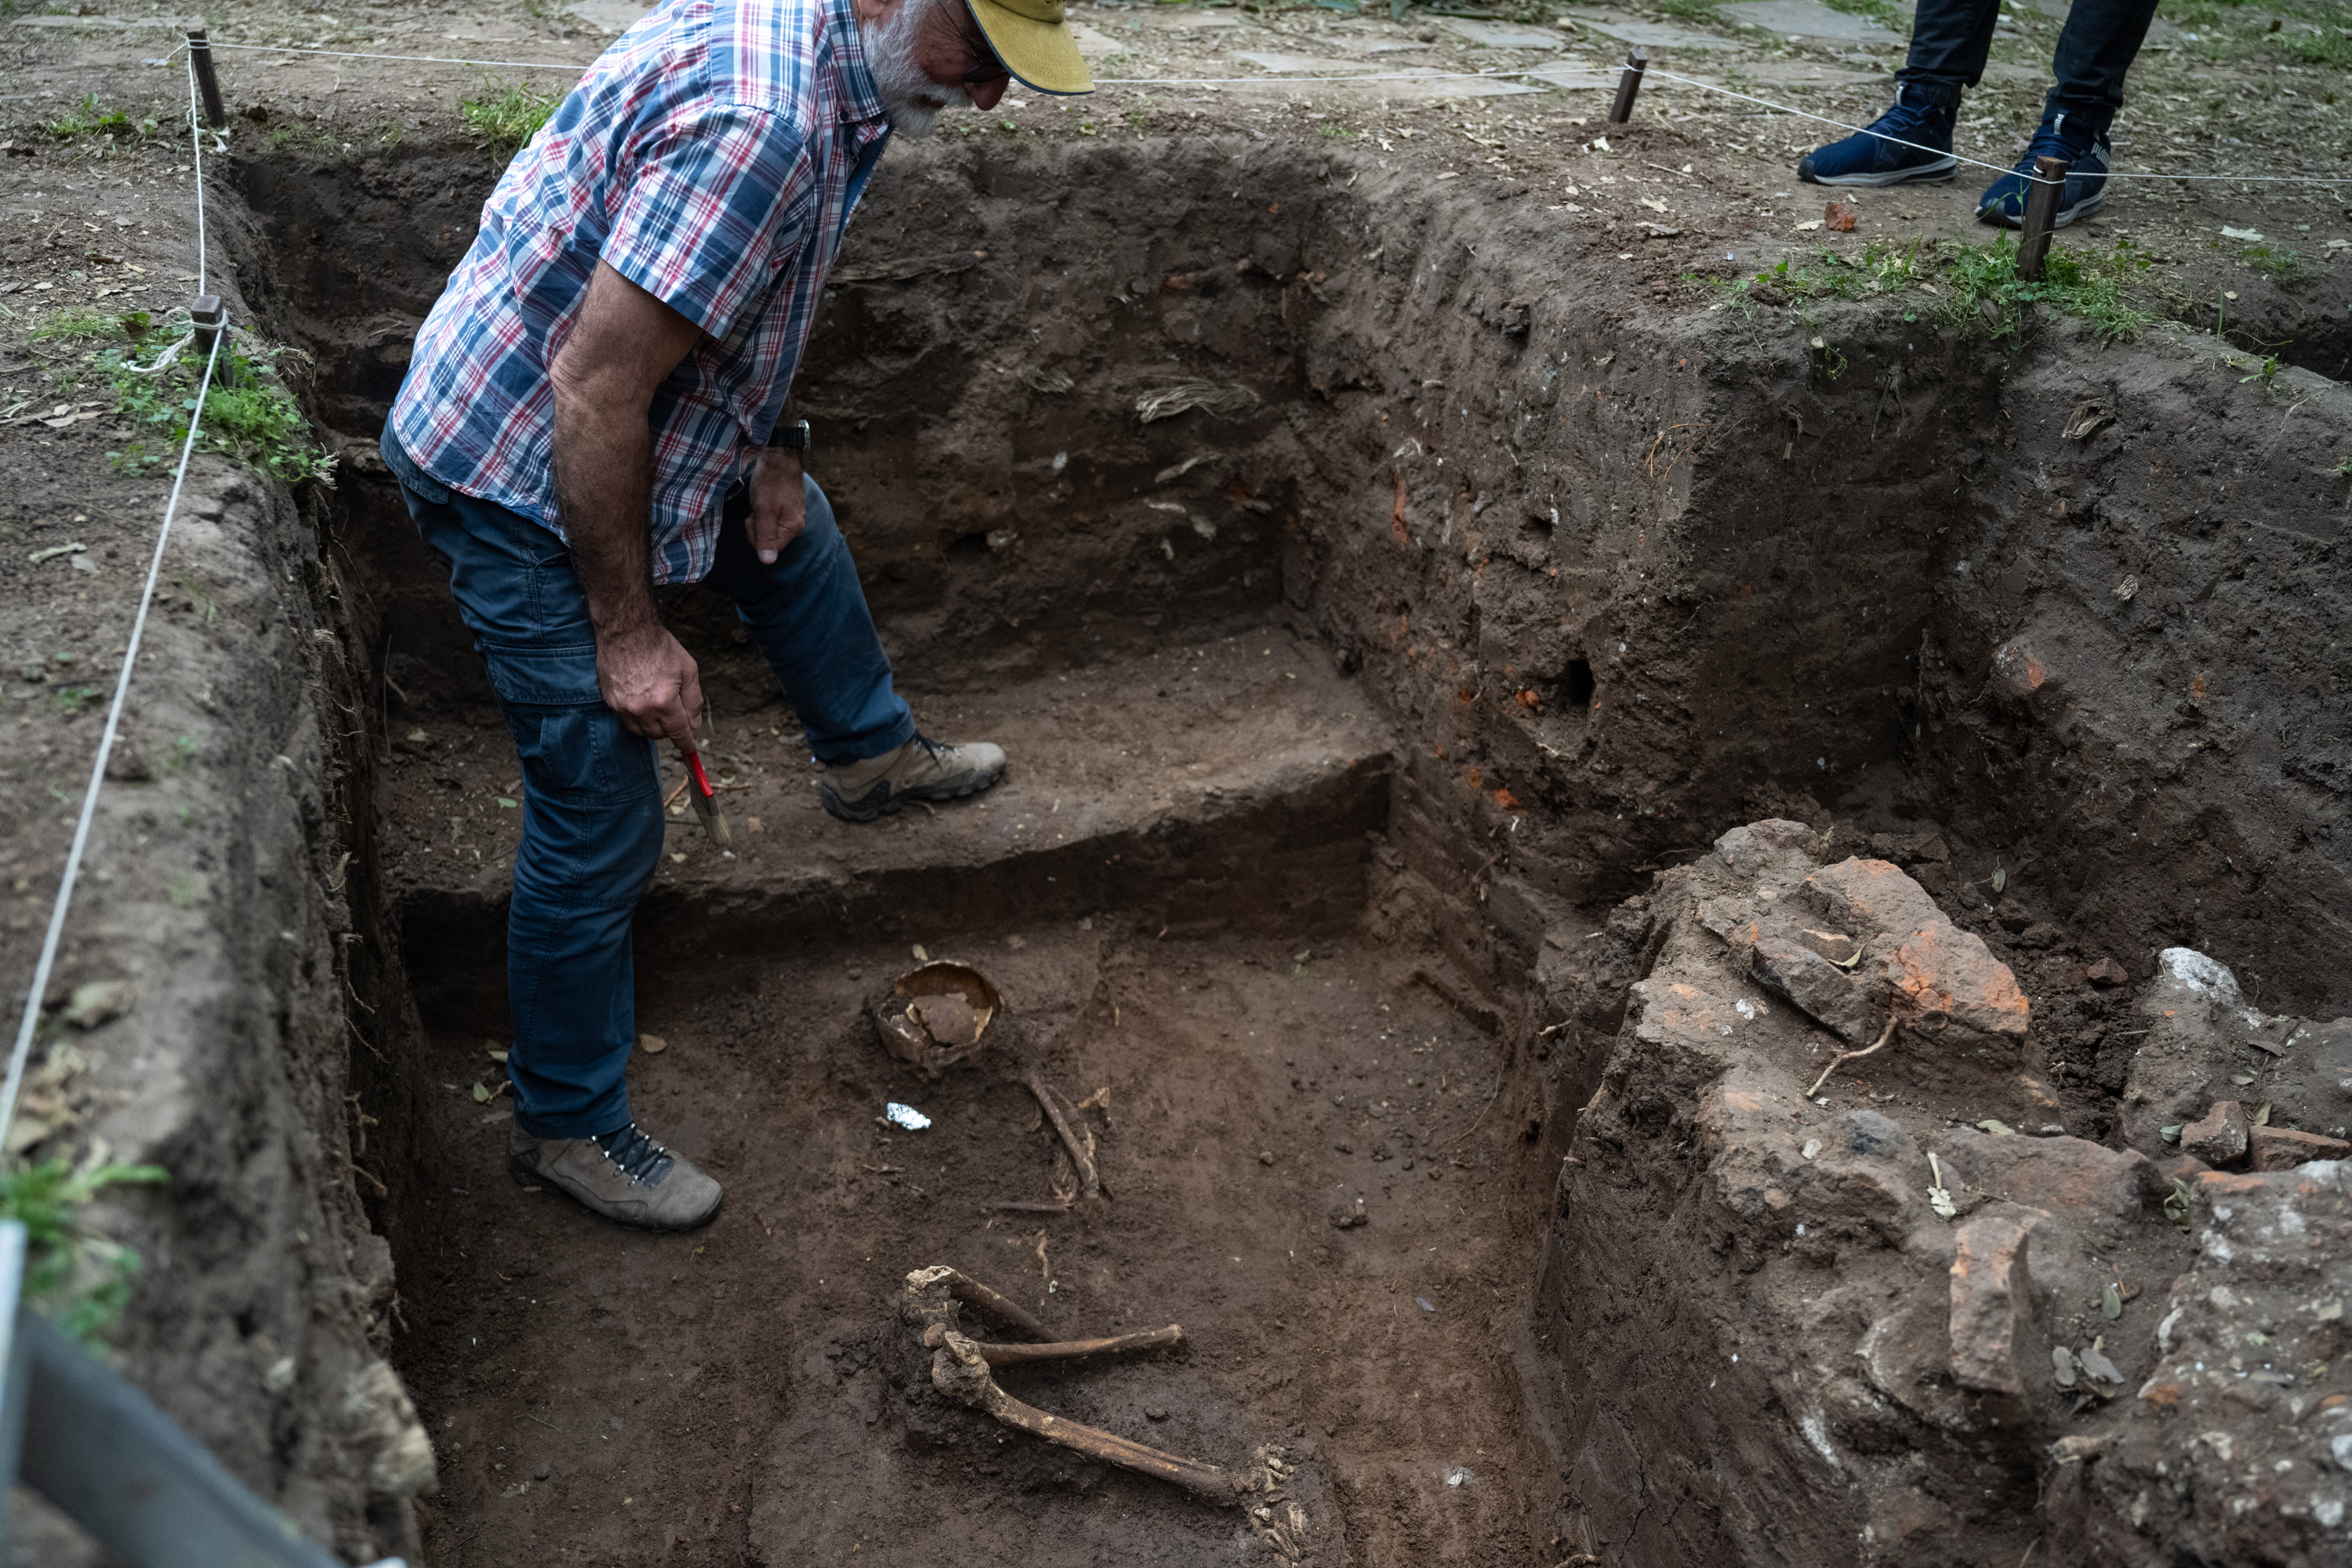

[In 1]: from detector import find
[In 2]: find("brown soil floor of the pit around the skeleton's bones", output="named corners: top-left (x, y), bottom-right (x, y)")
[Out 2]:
top-left (405, 916), bottom-right (1550, 1568)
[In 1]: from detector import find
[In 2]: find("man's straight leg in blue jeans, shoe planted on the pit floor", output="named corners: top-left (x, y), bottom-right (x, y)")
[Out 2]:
top-left (386, 432), bottom-right (720, 1229)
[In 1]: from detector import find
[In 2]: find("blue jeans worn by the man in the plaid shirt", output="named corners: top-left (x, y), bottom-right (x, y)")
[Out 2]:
top-left (383, 433), bottom-right (915, 1138)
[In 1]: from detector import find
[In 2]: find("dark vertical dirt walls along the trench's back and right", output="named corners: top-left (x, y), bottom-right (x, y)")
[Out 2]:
top-left (188, 139), bottom-right (2352, 1549)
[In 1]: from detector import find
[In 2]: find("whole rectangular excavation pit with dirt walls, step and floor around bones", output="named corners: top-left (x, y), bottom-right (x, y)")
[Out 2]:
top-left (212, 125), bottom-right (2352, 1563)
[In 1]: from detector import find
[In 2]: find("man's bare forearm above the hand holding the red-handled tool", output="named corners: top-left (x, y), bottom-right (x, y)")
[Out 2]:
top-left (555, 390), bottom-right (659, 642)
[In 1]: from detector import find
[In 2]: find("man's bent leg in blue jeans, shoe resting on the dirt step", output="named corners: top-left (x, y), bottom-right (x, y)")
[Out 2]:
top-left (703, 480), bottom-right (1004, 822)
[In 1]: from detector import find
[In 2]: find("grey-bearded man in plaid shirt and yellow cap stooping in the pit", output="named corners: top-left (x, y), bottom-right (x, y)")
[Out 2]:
top-left (383, 0), bottom-right (1091, 1229)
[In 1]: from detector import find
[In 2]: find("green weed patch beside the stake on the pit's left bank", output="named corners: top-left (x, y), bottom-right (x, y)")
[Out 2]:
top-left (94, 334), bottom-right (334, 485)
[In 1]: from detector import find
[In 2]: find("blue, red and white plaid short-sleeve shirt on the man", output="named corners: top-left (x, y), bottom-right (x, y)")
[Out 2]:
top-left (390, 0), bottom-right (889, 583)
